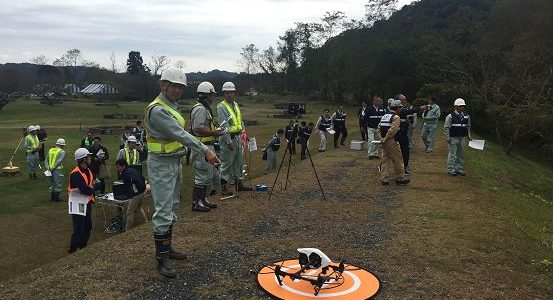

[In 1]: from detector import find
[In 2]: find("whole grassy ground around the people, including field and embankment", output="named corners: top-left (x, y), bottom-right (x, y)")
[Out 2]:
top-left (0, 96), bottom-right (552, 299)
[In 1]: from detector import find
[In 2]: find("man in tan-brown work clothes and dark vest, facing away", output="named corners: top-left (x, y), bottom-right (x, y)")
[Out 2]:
top-left (379, 100), bottom-right (410, 185)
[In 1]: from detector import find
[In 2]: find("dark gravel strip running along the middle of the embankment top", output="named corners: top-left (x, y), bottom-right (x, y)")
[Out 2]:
top-left (131, 157), bottom-right (396, 299)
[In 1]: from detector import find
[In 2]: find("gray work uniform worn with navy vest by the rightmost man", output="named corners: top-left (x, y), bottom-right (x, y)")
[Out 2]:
top-left (444, 112), bottom-right (471, 174)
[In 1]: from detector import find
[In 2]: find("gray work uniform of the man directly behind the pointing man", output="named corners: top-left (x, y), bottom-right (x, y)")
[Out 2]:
top-left (190, 101), bottom-right (219, 195)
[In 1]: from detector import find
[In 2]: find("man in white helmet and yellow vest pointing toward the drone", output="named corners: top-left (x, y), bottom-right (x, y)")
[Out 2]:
top-left (145, 67), bottom-right (219, 277)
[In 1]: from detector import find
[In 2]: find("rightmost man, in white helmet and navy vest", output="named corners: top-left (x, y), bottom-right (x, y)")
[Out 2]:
top-left (444, 98), bottom-right (471, 176)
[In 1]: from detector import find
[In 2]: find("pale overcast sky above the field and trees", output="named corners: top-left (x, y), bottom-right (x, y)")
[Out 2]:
top-left (0, 0), bottom-right (410, 72)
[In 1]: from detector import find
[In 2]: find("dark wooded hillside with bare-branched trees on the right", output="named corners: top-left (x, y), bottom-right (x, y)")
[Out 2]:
top-left (235, 0), bottom-right (552, 153)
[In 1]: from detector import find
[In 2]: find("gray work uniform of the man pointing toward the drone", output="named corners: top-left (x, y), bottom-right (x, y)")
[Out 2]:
top-left (145, 94), bottom-right (208, 234)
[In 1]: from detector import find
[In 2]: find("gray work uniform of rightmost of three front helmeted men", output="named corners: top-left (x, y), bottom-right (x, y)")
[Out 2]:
top-left (217, 100), bottom-right (246, 182)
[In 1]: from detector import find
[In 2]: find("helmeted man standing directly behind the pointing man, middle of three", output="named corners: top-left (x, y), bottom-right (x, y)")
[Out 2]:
top-left (190, 81), bottom-right (223, 212)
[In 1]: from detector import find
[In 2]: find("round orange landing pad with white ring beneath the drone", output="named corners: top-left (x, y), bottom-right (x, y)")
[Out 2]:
top-left (257, 259), bottom-right (381, 300)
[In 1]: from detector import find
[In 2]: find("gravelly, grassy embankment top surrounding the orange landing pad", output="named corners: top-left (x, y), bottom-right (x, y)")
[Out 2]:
top-left (0, 135), bottom-right (552, 299)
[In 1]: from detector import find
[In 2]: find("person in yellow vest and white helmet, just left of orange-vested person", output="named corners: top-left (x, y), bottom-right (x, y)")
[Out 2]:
top-left (44, 138), bottom-right (65, 202)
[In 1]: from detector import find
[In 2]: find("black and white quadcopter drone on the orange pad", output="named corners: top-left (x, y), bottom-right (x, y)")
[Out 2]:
top-left (274, 248), bottom-right (345, 296)
